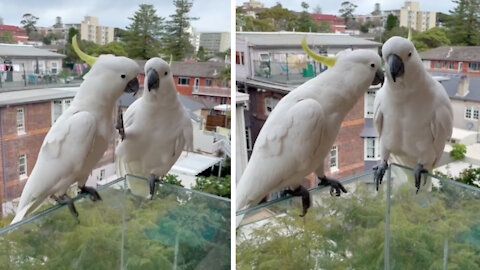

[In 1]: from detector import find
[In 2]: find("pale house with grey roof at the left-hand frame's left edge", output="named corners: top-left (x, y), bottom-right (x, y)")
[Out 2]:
top-left (0, 44), bottom-right (66, 82)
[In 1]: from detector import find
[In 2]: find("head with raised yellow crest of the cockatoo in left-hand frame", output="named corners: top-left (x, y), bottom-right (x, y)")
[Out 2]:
top-left (72, 36), bottom-right (141, 100)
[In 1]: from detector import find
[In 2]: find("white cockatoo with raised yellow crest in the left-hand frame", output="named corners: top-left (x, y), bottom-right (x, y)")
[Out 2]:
top-left (12, 37), bottom-right (140, 224)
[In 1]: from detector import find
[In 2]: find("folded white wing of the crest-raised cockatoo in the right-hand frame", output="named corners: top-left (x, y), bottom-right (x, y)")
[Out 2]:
top-left (237, 99), bottom-right (325, 210)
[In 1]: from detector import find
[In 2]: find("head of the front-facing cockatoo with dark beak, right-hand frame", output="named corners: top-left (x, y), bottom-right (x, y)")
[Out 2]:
top-left (382, 37), bottom-right (423, 84)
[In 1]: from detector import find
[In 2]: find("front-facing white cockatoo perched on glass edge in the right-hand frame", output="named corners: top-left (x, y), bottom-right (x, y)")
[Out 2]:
top-left (374, 37), bottom-right (453, 192)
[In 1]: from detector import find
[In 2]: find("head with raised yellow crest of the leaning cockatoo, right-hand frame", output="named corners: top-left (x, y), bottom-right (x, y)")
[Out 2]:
top-left (302, 39), bottom-right (384, 87)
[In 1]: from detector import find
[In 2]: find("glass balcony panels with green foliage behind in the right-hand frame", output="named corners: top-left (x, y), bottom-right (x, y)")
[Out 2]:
top-left (237, 165), bottom-right (480, 269)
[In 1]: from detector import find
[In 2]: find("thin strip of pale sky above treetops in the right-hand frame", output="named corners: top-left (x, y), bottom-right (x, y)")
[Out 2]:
top-left (236, 0), bottom-right (455, 14)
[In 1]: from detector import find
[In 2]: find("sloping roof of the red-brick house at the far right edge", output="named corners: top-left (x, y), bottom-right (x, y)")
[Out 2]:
top-left (420, 46), bottom-right (480, 62)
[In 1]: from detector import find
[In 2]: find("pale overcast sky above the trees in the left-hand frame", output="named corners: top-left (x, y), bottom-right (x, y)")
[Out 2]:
top-left (0, 0), bottom-right (230, 32)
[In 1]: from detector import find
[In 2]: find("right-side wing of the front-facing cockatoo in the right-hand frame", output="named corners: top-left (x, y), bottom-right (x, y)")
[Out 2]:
top-left (430, 100), bottom-right (453, 167)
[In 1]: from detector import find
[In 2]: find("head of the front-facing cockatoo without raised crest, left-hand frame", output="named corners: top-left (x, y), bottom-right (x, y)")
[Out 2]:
top-left (143, 57), bottom-right (176, 97)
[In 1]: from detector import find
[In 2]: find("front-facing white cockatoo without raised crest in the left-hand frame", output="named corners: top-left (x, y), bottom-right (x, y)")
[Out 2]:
top-left (115, 58), bottom-right (193, 197)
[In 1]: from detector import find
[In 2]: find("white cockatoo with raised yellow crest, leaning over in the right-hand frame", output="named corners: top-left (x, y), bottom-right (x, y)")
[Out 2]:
top-left (236, 39), bottom-right (383, 216)
